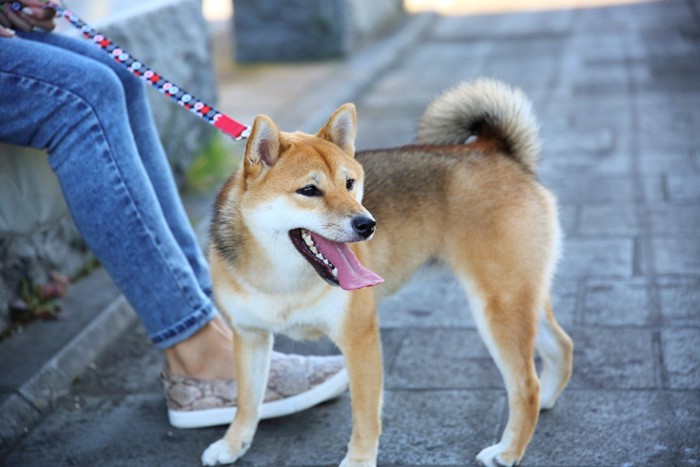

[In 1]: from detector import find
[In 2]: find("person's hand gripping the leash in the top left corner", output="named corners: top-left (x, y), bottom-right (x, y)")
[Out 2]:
top-left (0, 0), bottom-right (56, 37)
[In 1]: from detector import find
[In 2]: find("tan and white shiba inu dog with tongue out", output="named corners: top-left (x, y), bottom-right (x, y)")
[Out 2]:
top-left (202, 79), bottom-right (573, 466)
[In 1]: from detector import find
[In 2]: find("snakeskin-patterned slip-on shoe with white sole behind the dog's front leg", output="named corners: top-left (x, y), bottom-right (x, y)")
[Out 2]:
top-left (160, 352), bottom-right (348, 428)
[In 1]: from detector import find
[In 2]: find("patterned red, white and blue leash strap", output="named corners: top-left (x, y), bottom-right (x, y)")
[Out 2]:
top-left (22, 2), bottom-right (250, 141)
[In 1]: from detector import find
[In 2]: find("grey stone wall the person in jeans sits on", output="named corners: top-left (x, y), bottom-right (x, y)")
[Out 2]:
top-left (0, 0), bottom-right (217, 331)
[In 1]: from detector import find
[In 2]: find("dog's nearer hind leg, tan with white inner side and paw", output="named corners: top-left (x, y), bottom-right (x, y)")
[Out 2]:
top-left (467, 278), bottom-right (540, 466)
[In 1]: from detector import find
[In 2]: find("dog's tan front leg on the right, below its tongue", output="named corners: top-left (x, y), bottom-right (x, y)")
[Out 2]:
top-left (338, 298), bottom-right (383, 467)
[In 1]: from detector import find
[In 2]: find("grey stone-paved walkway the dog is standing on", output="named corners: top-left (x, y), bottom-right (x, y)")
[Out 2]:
top-left (0, 0), bottom-right (700, 466)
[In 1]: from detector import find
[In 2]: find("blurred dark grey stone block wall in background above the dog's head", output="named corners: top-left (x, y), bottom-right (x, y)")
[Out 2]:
top-left (234, 0), bottom-right (403, 62)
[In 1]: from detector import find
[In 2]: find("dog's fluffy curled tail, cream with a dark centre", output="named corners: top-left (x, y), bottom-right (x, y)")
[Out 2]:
top-left (418, 78), bottom-right (540, 172)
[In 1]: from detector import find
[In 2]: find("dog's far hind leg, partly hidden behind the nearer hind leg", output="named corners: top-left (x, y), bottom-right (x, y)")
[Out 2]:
top-left (535, 298), bottom-right (574, 410)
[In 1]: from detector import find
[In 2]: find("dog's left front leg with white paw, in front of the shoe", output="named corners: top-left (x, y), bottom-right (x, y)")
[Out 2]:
top-left (202, 330), bottom-right (272, 465)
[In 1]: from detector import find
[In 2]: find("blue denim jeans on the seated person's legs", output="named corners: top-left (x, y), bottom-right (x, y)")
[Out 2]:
top-left (0, 32), bottom-right (217, 348)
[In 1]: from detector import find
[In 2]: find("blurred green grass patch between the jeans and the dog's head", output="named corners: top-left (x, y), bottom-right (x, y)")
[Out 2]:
top-left (184, 134), bottom-right (245, 194)
